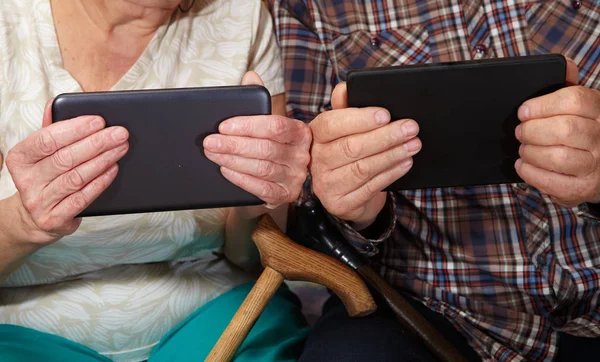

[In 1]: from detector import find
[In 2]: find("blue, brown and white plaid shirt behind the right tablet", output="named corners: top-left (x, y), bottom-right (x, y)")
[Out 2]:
top-left (269, 0), bottom-right (600, 361)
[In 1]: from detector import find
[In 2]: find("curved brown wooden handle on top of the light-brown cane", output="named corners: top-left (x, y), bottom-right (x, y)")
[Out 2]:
top-left (252, 215), bottom-right (377, 317)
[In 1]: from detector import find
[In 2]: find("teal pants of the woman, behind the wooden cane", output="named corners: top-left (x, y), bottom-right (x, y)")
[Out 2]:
top-left (0, 283), bottom-right (308, 362)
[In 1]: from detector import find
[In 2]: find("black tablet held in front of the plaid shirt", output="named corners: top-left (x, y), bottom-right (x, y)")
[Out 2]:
top-left (347, 54), bottom-right (566, 190)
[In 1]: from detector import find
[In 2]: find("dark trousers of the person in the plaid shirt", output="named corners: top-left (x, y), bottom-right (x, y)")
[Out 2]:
top-left (299, 296), bottom-right (600, 362)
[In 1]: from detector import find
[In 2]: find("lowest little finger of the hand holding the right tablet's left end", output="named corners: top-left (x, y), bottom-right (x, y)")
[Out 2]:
top-left (344, 158), bottom-right (413, 209)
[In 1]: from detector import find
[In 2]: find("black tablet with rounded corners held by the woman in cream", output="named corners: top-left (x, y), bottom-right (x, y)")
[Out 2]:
top-left (52, 86), bottom-right (271, 216)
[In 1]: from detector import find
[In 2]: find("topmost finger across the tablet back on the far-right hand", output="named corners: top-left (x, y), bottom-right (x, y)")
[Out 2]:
top-left (518, 86), bottom-right (600, 122)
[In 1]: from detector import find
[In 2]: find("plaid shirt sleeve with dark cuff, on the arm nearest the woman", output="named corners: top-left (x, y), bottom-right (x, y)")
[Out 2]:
top-left (269, 0), bottom-right (396, 256)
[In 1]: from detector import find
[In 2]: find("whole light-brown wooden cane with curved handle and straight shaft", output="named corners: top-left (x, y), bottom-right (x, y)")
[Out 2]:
top-left (205, 215), bottom-right (377, 362)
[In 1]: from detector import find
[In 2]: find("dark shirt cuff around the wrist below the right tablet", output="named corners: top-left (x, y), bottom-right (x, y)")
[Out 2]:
top-left (328, 192), bottom-right (397, 256)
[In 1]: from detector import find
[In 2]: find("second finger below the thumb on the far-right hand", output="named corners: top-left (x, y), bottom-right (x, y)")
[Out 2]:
top-left (515, 116), bottom-right (600, 150)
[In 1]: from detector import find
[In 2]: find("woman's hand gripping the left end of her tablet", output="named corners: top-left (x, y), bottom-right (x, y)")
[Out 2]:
top-left (6, 102), bottom-right (129, 244)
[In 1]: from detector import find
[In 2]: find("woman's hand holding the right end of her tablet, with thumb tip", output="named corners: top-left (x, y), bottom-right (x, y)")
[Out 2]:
top-left (204, 72), bottom-right (312, 211)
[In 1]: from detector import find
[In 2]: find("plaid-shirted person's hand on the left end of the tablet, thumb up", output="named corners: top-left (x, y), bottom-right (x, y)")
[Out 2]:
top-left (310, 83), bottom-right (421, 230)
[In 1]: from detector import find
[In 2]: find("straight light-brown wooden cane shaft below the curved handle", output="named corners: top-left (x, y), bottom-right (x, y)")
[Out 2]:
top-left (205, 267), bottom-right (283, 362)
